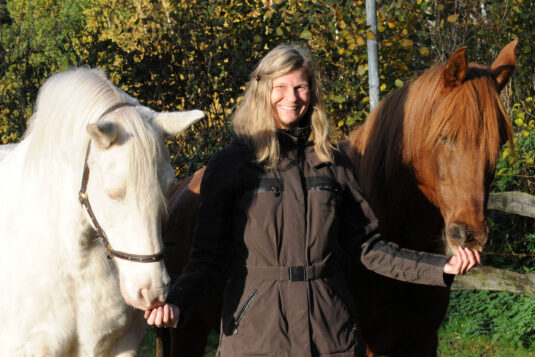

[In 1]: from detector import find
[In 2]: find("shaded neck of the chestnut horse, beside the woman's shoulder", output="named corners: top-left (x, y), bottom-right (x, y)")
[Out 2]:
top-left (344, 108), bottom-right (444, 252)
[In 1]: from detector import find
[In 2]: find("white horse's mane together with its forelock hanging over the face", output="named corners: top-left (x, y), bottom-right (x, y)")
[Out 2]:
top-left (24, 68), bottom-right (167, 211)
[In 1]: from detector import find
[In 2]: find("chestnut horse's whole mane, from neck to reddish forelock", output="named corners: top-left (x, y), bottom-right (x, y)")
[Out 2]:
top-left (349, 65), bottom-right (513, 184)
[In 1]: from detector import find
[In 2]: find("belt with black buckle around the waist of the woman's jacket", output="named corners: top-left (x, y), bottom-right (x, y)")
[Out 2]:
top-left (233, 264), bottom-right (338, 281)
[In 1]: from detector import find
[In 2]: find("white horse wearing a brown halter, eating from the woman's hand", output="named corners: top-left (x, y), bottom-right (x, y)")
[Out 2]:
top-left (0, 68), bottom-right (204, 357)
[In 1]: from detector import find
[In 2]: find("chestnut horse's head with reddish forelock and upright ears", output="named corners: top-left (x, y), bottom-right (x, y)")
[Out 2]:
top-left (403, 41), bottom-right (517, 252)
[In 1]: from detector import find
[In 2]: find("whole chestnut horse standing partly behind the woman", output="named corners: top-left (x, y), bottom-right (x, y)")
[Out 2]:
top-left (161, 41), bottom-right (517, 356)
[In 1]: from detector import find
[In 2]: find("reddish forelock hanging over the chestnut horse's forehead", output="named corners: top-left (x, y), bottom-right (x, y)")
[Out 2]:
top-left (402, 66), bottom-right (512, 166)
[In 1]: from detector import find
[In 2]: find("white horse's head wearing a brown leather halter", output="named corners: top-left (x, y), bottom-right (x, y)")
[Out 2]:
top-left (86, 103), bottom-right (204, 309)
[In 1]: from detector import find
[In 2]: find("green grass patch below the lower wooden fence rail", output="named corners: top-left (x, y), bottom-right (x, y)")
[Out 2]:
top-left (439, 291), bottom-right (535, 357)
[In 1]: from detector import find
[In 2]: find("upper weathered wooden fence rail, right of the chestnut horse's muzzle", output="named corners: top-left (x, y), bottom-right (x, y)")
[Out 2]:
top-left (487, 192), bottom-right (535, 218)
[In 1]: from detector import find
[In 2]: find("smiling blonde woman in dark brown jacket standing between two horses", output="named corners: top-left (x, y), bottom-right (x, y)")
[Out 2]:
top-left (145, 45), bottom-right (480, 356)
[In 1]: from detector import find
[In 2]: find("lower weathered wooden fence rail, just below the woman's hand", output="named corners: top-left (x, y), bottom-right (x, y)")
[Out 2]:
top-left (451, 266), bottom-right (535, 296)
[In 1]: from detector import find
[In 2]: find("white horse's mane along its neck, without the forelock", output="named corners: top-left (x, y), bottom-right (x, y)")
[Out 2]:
top-left (23, 68), bottom-right (132, 172)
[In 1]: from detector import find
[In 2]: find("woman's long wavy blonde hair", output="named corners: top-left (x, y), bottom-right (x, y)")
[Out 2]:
top-left (232, 45), bottom-right (333, 167)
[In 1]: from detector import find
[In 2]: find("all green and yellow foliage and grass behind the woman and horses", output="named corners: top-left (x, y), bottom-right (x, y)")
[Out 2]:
top-left (0, 0), bottom-right (535, 356)
